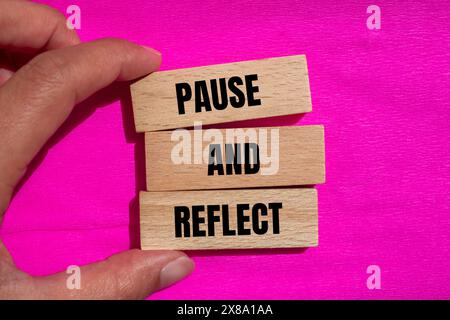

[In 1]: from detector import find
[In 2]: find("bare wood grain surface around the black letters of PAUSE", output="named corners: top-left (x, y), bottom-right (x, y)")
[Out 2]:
top-left (131, 55), bottom-right (312, 132)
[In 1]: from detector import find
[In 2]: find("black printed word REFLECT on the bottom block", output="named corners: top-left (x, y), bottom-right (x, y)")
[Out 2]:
top-left (174, 202), bottom-right (283, 238)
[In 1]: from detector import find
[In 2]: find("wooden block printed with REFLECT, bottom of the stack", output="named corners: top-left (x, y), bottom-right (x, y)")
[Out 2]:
top-left (140, 188), bottom-right (318, 250)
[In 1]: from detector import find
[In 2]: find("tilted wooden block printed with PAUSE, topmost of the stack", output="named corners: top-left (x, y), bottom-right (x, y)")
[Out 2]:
top-left (131, 55), bottom-right (311, 132)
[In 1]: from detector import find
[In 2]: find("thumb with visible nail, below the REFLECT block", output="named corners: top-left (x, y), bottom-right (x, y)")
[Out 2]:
top-left (0, 249), bottom-right (194, 299)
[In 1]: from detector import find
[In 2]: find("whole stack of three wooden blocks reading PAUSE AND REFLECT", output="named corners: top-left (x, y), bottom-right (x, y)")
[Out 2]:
top-left (131, 55), bottom-right (325, 250)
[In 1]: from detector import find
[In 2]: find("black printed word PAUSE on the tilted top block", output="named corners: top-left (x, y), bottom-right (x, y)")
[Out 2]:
top-left (175, 74), bottom-right (261, 114)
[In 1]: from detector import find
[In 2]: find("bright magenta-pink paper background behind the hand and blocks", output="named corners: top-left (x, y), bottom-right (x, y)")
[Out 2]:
top-left (1, 0), bottom-right (450, 299)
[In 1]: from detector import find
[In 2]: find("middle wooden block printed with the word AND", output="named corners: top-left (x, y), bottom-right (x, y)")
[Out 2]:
top-left (145, 125), bottom-right (325, 191)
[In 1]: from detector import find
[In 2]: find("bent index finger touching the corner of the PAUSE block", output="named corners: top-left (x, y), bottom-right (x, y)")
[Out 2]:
top-left (0, 39), bottom-right (161, 213)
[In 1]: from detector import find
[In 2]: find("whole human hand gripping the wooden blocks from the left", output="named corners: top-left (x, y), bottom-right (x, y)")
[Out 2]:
top-left (0, 0), bottom-right (194, 299)
